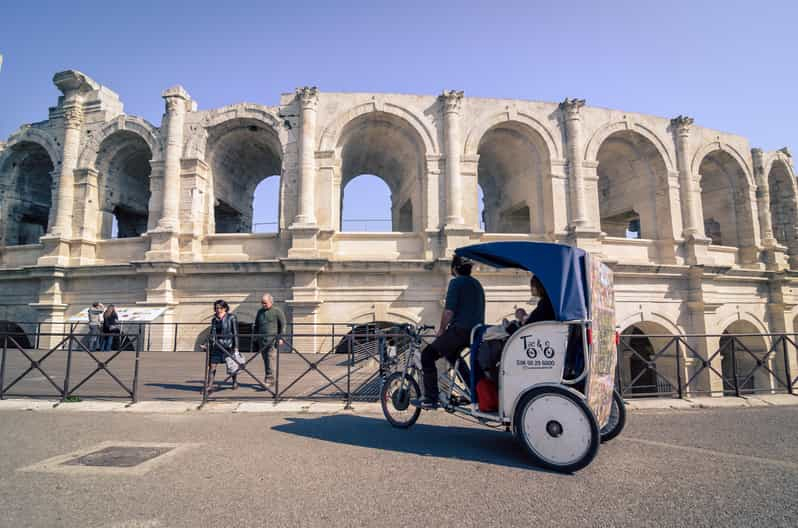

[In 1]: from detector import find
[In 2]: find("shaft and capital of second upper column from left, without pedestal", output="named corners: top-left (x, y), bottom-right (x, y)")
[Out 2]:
top-left (156, 86), bottom-right (191, 232)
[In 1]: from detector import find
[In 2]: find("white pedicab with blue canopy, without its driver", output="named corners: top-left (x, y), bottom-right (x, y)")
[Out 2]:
top-left (381, 242), bottom-right (625, 472)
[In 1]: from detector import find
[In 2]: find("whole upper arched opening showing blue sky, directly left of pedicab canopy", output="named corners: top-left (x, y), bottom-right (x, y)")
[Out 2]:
top-left (338, 112), bottom-right (424, 232)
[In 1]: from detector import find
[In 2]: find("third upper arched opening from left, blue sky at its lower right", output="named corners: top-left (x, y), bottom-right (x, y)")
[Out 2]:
top-left (207, 119), bottom-right (282, 233)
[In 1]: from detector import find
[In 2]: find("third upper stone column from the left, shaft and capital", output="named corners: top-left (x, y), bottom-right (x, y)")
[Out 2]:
top-left (294, 86), bottom-right (319, 226)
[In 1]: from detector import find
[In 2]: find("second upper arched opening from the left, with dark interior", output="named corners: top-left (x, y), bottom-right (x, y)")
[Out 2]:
top-left (97, 130), bottom-right (152, 238)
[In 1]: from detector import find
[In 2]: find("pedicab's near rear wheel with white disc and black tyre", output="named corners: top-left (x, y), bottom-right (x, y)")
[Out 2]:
top-left (513, 386), bottom-right (600, 473)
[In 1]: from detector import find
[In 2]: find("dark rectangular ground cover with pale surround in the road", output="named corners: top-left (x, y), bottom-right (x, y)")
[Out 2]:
top-left (17, 441), bottom-right (199, 475)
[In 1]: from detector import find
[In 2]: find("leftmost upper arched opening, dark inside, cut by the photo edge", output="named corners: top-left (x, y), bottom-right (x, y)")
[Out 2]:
top-left (0, 141), bottom-right (53, 246)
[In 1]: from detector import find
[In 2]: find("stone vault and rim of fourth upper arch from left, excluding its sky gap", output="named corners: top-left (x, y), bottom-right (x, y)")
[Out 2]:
top-left (332, 109), bottom-right (426, 232)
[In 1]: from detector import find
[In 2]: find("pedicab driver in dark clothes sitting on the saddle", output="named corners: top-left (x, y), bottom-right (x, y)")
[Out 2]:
top-left (418, 255), bottom-right (485, 409)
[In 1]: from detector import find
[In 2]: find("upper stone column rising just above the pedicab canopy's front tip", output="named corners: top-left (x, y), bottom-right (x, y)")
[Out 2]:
top-left (440, 90), bottom-right (465, 227)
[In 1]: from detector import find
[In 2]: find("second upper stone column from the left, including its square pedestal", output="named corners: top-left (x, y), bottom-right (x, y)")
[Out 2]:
top-left (146, 86), bottom-right (191, 262)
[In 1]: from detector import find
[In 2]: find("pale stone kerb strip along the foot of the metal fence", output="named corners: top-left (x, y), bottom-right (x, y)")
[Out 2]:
top-left (0, 394), bottom-right (798, 414)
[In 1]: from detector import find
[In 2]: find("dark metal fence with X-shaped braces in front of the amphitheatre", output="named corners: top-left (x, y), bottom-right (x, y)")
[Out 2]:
top-left (0, 322), bottom-right (798, 403)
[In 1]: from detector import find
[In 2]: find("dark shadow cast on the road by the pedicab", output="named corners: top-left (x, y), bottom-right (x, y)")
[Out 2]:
top-left (272, 414), bottom-right (560, 473)
